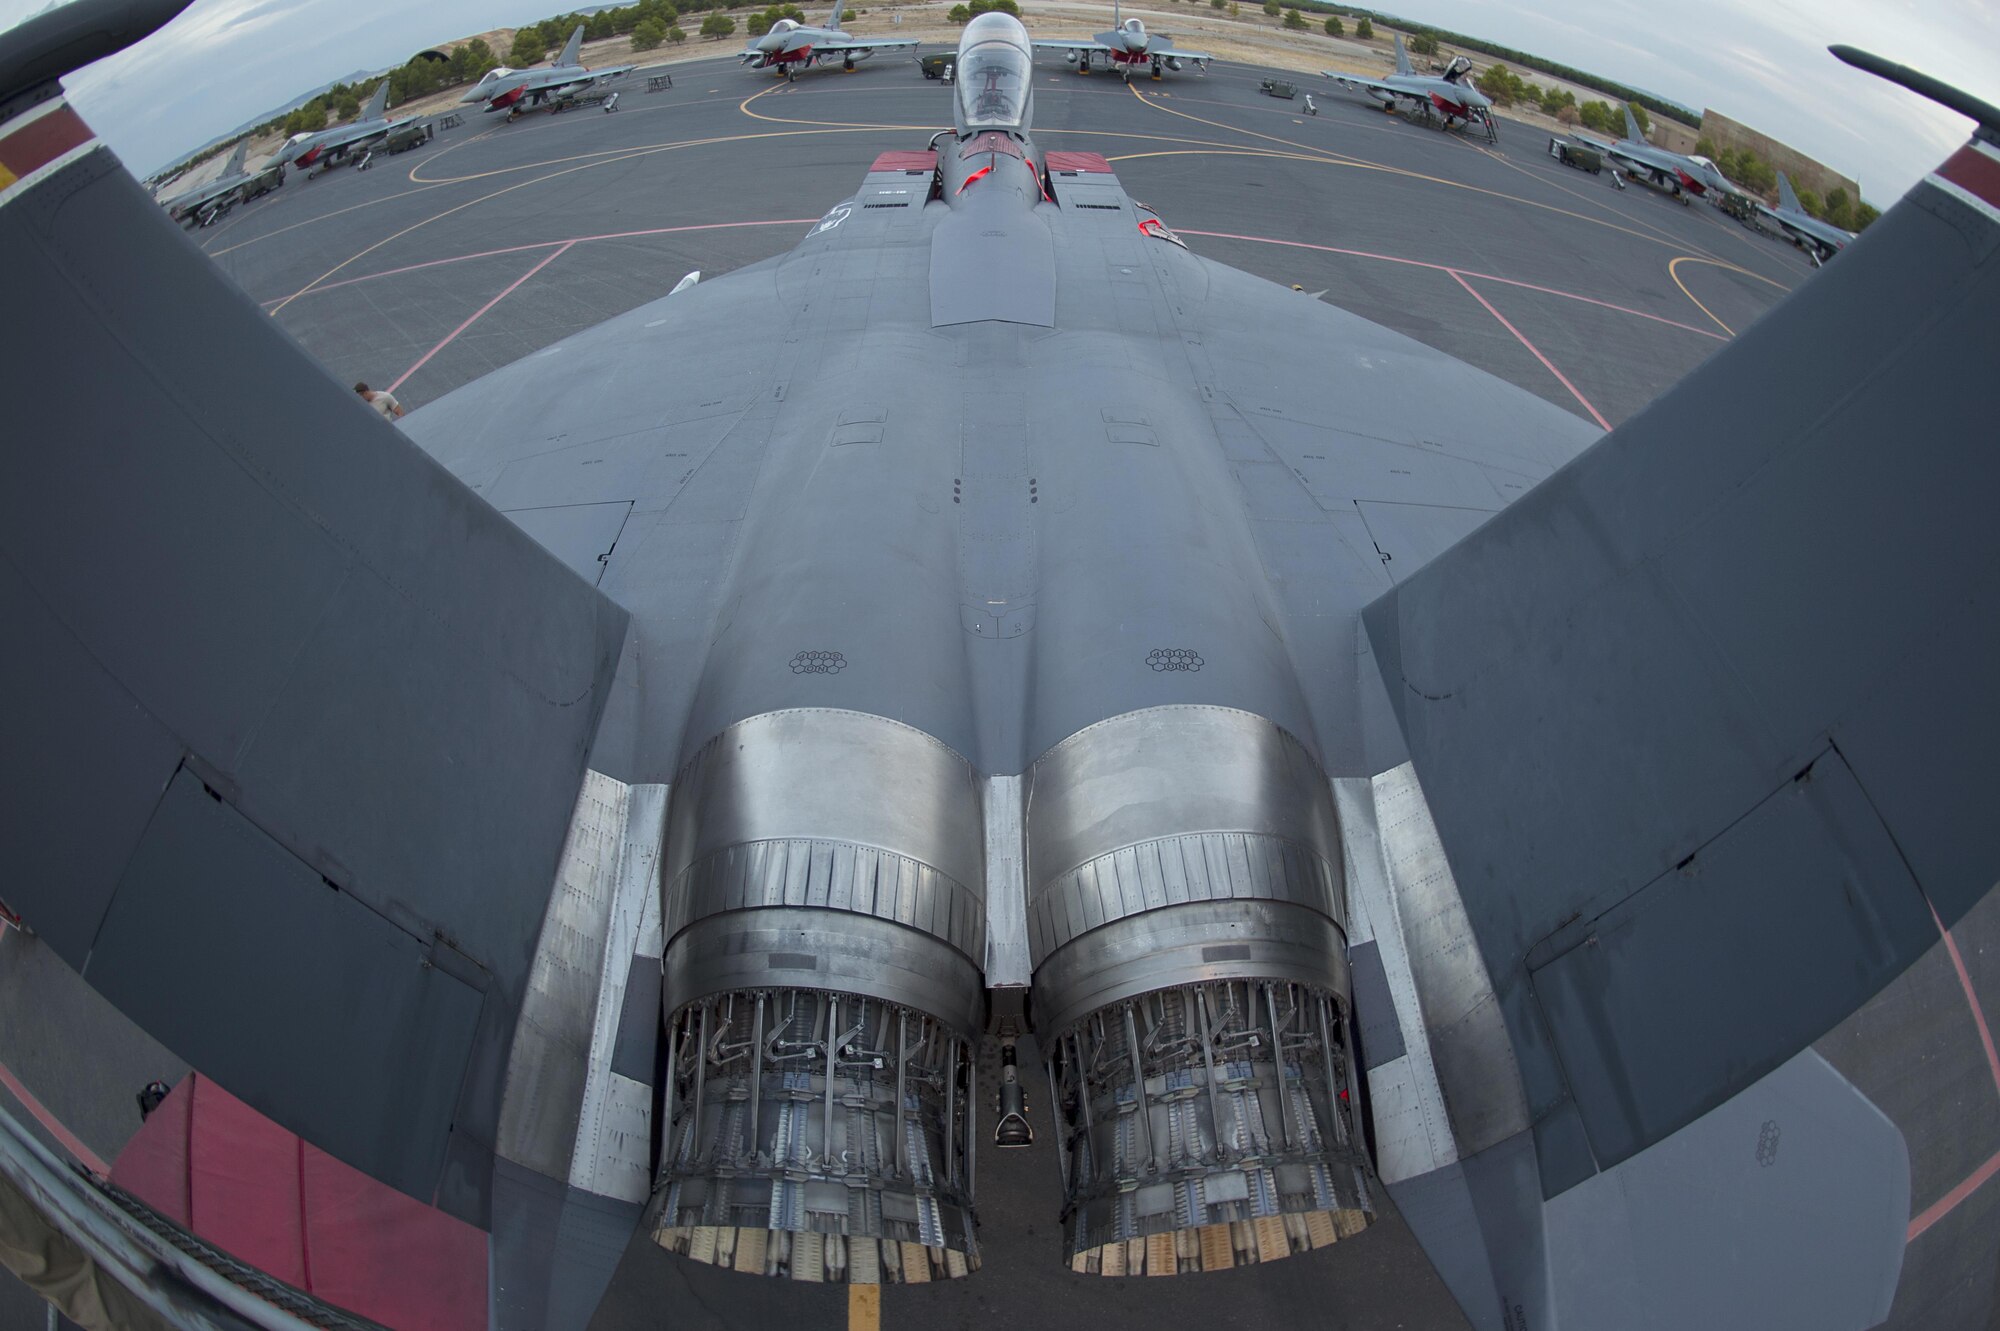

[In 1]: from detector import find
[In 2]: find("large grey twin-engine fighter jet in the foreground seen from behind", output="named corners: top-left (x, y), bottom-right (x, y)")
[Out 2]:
top-left (0, 0), bottom-right (2000, 1329)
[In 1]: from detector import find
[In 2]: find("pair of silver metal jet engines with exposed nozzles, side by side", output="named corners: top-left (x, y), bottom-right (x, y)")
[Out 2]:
top-left (656, 707), bottom-right (1372, 1281)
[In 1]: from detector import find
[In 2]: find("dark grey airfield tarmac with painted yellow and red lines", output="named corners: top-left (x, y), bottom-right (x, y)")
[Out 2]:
top-left (0, 46), bottom-right (2000, 1331)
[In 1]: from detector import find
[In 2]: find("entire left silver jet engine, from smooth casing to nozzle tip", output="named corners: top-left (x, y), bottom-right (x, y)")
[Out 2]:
top-left (654, 709), bottom-right (986, 1283)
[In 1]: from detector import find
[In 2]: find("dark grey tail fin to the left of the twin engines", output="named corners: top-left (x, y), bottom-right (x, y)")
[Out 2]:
top-left (0, 43), bottom-right (626, 1223)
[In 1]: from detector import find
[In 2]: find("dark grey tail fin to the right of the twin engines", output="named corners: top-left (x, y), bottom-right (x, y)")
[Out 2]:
top-left (1364, 74), bottom-right (2000, 1195)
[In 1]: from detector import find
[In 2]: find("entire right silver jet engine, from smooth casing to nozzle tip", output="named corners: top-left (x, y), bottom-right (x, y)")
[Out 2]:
top-left (1026, 705), bottom-right (1374, 1275)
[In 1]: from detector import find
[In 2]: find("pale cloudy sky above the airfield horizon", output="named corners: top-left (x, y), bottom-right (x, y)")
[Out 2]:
top-left (0, 0), bottom-right (2000, 196)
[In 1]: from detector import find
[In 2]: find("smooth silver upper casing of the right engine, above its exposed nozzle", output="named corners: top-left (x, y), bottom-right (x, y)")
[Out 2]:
top-left (1028, 707), bottom-right (1348, 1031)
